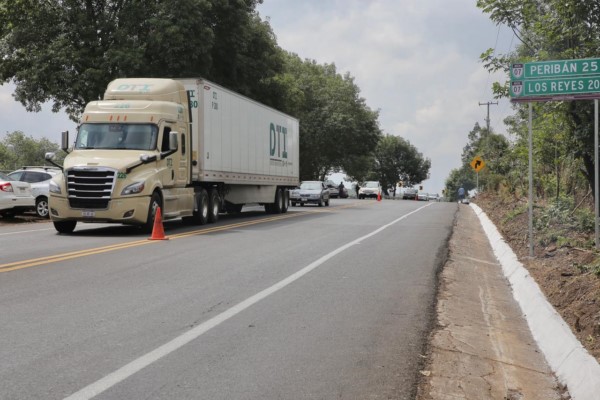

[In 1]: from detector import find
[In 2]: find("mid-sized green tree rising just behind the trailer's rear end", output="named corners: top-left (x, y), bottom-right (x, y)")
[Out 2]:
top-left (277, 54), bottom-right (381, 180)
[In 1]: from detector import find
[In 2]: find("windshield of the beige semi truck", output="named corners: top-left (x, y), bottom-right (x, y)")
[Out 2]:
top-left (75, 123), bottom-right (158, 150)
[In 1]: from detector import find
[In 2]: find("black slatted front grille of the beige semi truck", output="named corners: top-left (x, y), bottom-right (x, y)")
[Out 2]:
top-left (67, 168), bottom-right (116, 210)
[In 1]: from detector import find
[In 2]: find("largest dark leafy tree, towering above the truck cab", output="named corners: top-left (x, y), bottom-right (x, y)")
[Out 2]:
top-left (0, 0), bottom-right (283, 120)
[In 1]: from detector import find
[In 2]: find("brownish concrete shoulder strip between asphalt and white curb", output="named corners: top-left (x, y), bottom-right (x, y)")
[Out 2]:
top-left (417, 205), bottom-right (568, 400)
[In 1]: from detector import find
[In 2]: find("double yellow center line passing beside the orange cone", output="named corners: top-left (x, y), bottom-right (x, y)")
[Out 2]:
top-left (0, 203), bottom-right (366, 273)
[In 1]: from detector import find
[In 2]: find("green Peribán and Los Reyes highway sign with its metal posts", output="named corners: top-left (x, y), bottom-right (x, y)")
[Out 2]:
top-left (509, 58), bottom-right (600, 252)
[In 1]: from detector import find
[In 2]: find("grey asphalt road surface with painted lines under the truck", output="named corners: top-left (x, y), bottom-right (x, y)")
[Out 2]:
top-left (0, 199), bottom-right (457, 400)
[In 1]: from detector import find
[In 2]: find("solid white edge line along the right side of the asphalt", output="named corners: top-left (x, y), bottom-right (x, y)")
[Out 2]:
top-left (65, 203), bottom-right (433, 400)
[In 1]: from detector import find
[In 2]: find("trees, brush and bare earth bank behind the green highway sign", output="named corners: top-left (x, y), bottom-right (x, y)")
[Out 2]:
top-left (445, 0), bottom-right (600, 360)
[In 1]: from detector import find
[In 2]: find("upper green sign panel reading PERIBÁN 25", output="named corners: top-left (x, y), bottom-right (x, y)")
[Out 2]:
top-left (510, 58), bottom-right (600, 81)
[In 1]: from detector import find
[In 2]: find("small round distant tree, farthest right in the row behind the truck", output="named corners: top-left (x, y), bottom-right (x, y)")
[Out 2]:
top-left (372, 135), bottom-right (431, 194)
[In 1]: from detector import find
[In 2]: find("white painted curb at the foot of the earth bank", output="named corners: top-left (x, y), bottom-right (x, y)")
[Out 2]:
top-left (471, 203), bottom-right (600, 400)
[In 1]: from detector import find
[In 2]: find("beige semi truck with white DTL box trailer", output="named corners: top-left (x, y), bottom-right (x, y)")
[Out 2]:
top-left (46, 78), bottom-right (299, 233)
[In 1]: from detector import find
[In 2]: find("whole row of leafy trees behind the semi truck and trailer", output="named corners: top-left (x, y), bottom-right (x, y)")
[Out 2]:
top-left (0, 0), bottom-right (430, 186)
